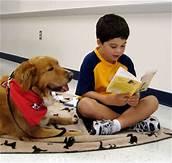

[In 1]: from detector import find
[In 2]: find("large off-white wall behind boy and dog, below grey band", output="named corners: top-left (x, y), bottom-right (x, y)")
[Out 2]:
top-left (0, 1), bottom-right (172, 92)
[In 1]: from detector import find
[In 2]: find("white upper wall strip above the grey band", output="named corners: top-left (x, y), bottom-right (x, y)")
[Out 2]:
top-left (0, 0), bottom-right (171, 14)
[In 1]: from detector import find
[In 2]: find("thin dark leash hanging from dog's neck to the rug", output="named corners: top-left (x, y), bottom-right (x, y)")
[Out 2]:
top-left (7, 77), bottom-right (66, 139)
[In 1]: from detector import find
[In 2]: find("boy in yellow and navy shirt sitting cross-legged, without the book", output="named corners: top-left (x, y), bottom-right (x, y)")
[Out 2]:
top-left (76, 14), bottom-right (159, 135)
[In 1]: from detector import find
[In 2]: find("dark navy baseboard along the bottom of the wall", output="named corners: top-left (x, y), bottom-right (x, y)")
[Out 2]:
top-left (0, 52), bottom-right (172, 107)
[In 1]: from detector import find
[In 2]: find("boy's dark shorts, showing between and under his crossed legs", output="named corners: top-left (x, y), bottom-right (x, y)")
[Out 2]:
top-left (76, 102), bottom-right (130, 131)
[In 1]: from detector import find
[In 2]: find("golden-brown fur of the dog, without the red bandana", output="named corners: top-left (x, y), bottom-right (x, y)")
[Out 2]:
top-left (0, 56), bottom-right (80, 139)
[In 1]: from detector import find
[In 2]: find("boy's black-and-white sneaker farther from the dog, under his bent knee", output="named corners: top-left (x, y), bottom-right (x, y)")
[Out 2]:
top-left (133, 116), bottom-right (160, 133)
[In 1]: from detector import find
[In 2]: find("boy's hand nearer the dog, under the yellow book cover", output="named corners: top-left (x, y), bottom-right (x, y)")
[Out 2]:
top-left (104, 93), bottom-right (130, 106)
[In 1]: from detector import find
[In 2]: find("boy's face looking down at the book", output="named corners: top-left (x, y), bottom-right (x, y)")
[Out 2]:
top-left (97, 38), bottom-right (127, 63)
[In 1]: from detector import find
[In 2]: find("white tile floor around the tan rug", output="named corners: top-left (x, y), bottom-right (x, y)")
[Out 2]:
top-left (0, 80), bottom-right (172, 163)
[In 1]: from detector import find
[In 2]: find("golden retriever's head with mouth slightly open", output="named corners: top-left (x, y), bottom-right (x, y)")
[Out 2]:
top-left (13, 56), bottom-right (73, 96)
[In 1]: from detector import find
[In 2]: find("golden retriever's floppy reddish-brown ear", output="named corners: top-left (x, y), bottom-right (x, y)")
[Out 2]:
top-left (14, 61), bottom-right (36, 91)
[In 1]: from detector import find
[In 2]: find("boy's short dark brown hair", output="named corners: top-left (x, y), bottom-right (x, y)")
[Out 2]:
top-left (96, 14), bottom-right (130, 44)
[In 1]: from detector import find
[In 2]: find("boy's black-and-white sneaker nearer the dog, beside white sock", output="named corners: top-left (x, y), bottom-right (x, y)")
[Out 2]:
top-left (90, 120), bottom-right (114, 135)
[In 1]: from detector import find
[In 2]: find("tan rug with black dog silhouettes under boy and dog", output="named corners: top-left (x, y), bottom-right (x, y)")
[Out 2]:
top-left (0, 92), bottom-right (172, 154)
